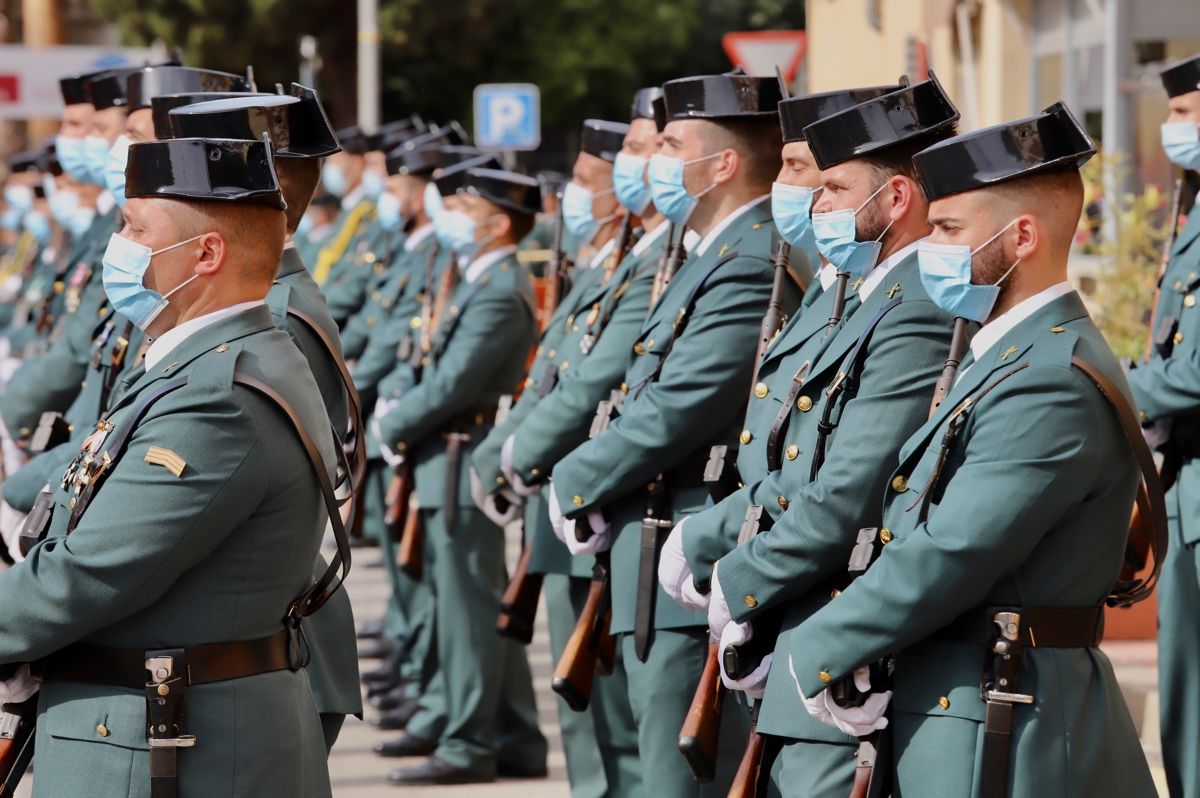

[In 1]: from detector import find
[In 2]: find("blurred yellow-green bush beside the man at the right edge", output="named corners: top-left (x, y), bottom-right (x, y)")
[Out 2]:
top-left (1076, 154), bottom-right (1171, 360)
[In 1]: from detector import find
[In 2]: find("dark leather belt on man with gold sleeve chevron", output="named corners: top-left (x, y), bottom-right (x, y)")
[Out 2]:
top-left (40, 629), bottom-right (290, 690)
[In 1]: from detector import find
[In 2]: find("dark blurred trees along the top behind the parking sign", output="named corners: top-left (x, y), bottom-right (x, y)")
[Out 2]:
top-left (90, 0), bottom-right (804, 144)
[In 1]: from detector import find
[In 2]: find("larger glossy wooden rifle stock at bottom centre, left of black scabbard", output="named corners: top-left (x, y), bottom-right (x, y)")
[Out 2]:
top-left (551, 552), bottom-right (617, 712)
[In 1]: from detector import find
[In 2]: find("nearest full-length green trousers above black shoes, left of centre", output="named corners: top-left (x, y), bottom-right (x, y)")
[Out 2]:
top-left (421, 506), bottom-right (546, 776)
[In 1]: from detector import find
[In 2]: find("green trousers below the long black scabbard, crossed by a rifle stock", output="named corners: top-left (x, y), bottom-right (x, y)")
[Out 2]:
top-left (618, 628), bottom-right (750, 798)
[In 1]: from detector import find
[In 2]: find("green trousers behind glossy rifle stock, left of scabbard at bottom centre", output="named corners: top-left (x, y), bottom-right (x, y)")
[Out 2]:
top-left (542, 574), bottom-right (644, 798)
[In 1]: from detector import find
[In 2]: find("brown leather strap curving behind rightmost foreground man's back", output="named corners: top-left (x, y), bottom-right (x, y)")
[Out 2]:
top-left (1070, 355), bottom-right (1168, 606)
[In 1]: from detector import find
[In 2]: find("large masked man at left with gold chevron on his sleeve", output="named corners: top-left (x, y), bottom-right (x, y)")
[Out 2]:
top-left (0, 133), bottom-right (348, 797)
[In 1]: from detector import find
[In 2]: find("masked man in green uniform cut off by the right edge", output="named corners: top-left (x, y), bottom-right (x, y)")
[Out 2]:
top-left (1129, 55), bottom-right (1200, 798)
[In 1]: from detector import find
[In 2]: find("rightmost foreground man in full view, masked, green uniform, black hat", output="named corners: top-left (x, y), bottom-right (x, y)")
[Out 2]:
top-left (787, 103), bottom-right (1165, 798)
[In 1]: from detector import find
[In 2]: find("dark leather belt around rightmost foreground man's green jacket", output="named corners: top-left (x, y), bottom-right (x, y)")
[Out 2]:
top-left (932, 607), bottom-right (1104, 648)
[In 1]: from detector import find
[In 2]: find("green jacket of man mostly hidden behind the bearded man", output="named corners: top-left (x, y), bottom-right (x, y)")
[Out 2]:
top-left (684, 271), bottom-right (860, 583)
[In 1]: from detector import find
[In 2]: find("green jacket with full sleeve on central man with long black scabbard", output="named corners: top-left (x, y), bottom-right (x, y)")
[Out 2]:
top-left (552, 202), bottom-right (799, 634)
